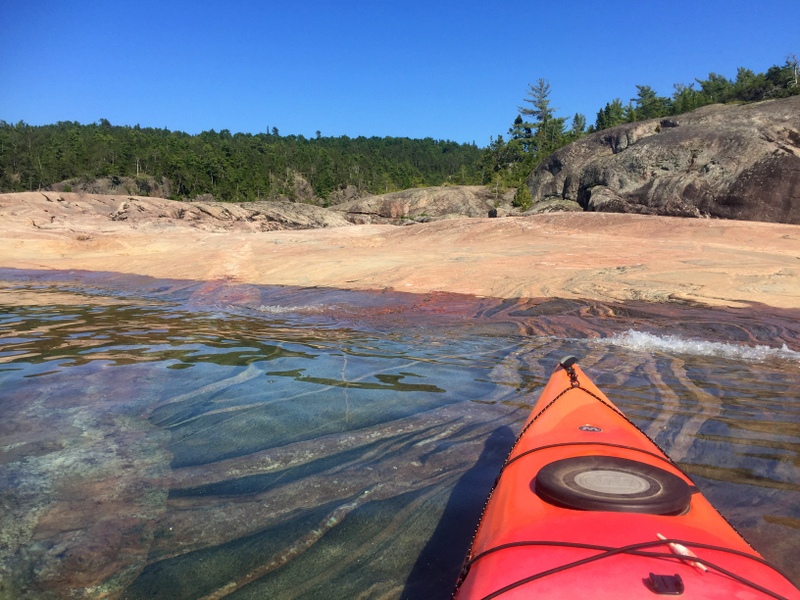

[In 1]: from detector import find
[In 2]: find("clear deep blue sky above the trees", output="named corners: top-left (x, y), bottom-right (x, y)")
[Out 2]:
top-left (0, 0), bottom-right (800, 146)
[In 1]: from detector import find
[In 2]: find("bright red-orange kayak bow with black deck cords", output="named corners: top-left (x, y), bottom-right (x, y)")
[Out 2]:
top-left (455, 357), bottom-right (800, 600)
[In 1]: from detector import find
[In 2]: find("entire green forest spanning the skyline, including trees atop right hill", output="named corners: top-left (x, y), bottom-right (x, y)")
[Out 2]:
top-left (0, 55), bottom-right (800, 207)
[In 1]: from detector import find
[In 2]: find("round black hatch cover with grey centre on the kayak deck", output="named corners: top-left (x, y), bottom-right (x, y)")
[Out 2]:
top-left (532, 456), bottom-right (692, 515)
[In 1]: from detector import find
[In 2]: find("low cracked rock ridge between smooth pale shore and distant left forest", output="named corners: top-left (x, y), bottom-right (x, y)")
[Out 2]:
top-left (0, 186), bottom-right (514, 231)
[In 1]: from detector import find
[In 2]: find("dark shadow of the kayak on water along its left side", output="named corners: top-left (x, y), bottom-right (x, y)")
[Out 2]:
top-left (401, 426), bottom-right (514, 600)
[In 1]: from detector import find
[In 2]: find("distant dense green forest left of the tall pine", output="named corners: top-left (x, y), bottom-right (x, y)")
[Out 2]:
top-left (0, 119), bottom-right (481, 204)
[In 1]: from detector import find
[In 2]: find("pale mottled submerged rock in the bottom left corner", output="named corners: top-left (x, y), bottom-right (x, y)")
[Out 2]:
top-left (0, 374), bottom-right (170, 600)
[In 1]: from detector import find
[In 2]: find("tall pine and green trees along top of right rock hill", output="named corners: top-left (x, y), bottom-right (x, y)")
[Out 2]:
top-left (480, 55), bottom-right (800, 208)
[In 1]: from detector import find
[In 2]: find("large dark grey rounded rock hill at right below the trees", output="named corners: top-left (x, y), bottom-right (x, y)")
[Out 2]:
top-left (527, 96), bottom-right (800, 224)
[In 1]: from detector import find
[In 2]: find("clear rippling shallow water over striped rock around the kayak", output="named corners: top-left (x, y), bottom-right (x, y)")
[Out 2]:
top-left (0, 270), bottom-right (800, 600)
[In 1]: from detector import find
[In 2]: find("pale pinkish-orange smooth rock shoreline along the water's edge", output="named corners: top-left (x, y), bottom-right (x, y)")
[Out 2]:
top-left (0, 192), bottom-right (800, 308)
